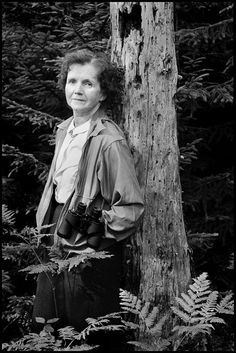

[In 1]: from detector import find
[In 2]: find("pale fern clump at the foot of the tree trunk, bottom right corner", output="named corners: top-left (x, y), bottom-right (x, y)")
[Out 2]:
top-left (120, 272), bottom-right (233, 351)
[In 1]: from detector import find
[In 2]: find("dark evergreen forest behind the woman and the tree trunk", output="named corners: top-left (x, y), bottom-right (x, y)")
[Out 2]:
top-left (1, 1), bottom-right (234, 350)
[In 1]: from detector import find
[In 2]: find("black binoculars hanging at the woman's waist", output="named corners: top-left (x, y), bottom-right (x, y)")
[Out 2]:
top-left (57, 202), bottom-right (104, 249)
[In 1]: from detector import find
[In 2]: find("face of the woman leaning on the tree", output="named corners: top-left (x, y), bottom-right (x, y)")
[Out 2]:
top-left (65, 63), bottom-right (105, 116)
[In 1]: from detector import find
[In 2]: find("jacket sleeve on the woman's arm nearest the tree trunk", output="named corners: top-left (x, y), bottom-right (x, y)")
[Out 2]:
top-left (98, 140), bottom-right (144, 241)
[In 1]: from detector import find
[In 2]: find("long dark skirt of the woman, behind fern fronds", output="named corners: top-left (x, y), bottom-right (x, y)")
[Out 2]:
top-left (33, 207), bottom-right (122, 331)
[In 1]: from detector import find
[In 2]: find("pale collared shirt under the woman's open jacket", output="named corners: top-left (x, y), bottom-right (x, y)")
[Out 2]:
top-left (53, 119), bottom-right (91, 203)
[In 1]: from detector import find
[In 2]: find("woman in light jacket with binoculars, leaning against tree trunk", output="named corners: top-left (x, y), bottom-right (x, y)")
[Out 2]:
top-left (33, 49), bottom-right (143, 344)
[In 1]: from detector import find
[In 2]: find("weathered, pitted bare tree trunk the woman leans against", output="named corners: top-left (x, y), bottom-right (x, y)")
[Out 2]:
top-left (110, 2), bottom-right (190, 328)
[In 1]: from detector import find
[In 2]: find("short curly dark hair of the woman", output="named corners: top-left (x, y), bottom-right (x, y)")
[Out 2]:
top-left (58, 49), bottom-right (124, 122)
